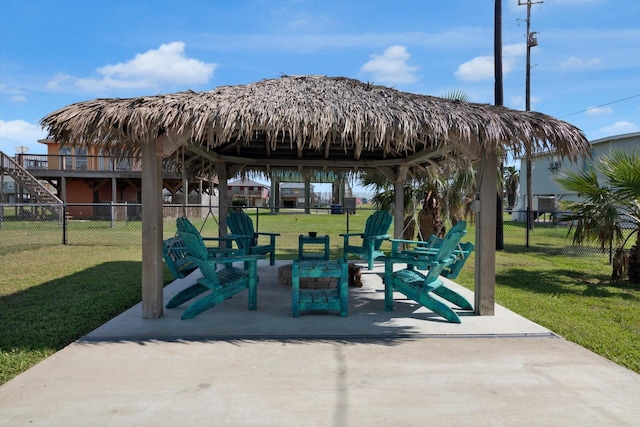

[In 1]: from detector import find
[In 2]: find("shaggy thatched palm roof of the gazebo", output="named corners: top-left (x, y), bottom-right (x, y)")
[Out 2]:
top-left (41, 76), bottom-right (589, 176)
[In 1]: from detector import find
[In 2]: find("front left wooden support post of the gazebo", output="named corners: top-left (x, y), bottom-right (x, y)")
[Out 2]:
top-left (142, 136), bottom-right (163, 319)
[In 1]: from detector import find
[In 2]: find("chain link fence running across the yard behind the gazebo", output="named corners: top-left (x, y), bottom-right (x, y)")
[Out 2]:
top-left (0, 203), bottom-right (610, 263)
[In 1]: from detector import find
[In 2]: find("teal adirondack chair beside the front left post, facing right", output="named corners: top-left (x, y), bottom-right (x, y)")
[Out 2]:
top-left (166, 231), bottom-right (262, 319)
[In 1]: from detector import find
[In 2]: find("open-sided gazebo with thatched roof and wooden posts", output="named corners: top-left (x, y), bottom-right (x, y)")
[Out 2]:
top-left (41, 76), bottom-right (589, 318)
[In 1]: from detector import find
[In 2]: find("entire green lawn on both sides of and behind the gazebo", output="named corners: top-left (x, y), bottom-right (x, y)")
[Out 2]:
top-left (0, 211), bottom-right (640, 384)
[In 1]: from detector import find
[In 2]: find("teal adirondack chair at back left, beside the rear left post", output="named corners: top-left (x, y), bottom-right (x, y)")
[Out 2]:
top-left (227, 211), bottom-right (280, 265)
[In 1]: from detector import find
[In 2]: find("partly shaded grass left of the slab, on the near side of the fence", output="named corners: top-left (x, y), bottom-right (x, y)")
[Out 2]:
top-left (0, 245), bottom-right (170, 383)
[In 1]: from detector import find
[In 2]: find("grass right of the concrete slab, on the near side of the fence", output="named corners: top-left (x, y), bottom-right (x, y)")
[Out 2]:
top-left (457, 249), bottom-right (640, 373)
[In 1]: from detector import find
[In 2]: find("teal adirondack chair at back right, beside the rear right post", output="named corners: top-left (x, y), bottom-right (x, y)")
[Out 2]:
top-left (341, 211), bottom-right (393, 270)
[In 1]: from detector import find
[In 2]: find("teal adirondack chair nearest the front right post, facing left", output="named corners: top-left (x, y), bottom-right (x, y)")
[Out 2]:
top-left (384, 221), bottom-right (473, 323)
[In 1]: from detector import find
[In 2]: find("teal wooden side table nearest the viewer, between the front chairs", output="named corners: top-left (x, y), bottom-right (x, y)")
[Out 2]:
top-left (291, 259), bottom-right (349, 317)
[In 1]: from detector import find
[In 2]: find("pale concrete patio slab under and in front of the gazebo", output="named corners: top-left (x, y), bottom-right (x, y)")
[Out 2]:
top-left (0, 265), bottom-right (640, 427)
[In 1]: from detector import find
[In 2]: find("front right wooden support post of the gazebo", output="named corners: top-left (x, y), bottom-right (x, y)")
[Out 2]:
top-left (475, 149), bottom-right (498, 316)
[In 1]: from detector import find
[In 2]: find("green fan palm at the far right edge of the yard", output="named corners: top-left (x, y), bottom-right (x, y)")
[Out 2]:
top-left (557, 150), bottom-right (640, 283)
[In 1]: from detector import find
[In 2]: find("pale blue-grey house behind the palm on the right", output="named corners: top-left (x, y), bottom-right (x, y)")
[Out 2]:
top-left (512, 132), bottom-right (640, 221)
